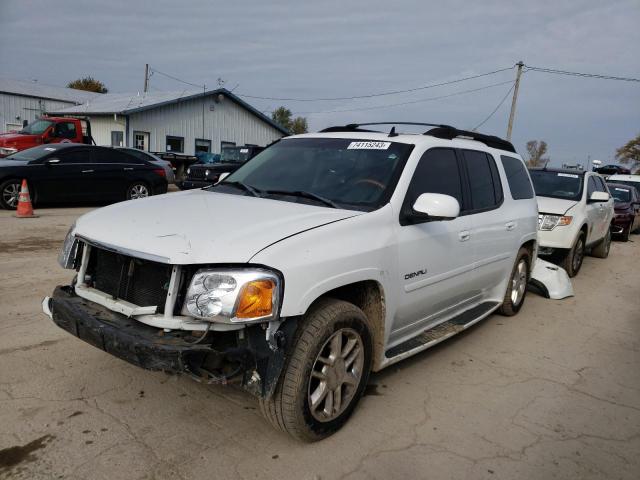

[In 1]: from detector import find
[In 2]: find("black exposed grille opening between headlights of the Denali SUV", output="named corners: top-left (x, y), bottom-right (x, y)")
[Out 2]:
top-left (86, 247), bottom-right (172, 313)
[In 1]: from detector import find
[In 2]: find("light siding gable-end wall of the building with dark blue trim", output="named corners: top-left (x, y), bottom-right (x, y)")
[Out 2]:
top-left (127, 96), bottom-right (283, 155)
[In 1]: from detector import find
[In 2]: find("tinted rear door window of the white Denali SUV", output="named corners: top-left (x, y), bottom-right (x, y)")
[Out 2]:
top-left (464, 150), bottom-right (502, 210)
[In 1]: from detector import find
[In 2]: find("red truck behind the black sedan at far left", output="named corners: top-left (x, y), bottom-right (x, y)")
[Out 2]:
top-left (0, 117), bottom-right (95, 157)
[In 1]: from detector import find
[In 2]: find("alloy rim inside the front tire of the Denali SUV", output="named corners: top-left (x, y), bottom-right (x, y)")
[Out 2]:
top-left (307, 328), bottom-right (364, 422)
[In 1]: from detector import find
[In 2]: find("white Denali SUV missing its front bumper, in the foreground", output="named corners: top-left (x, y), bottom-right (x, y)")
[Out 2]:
top-left (43, 124), bottom-right (538, 441)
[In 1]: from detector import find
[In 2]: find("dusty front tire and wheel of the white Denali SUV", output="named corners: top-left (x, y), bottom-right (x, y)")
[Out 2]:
top-left (260, 298), bottom-right (372, 442)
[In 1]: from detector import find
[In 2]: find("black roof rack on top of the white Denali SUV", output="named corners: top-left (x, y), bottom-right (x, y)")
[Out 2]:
top-left (320, 122), bottom-right (516, 153)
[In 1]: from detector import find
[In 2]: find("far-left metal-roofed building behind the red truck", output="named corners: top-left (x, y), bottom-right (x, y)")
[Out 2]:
top-left (0, 78), bottom-right (101, 132)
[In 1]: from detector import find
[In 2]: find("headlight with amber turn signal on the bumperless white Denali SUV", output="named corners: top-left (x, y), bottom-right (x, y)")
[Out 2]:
top-left (182, 269), bottom-right (281, 323)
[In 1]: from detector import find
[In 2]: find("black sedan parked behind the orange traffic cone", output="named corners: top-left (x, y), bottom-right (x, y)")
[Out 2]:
top-left (0, 143), bottom-right (167, 210)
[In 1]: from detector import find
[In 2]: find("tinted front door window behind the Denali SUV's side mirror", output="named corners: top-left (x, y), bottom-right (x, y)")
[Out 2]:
top-left (407, 148), bottom-right (463, 208)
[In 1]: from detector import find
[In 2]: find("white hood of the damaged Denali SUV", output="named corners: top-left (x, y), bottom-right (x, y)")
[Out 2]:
top-left (75, 190), bottom-right (362, 265)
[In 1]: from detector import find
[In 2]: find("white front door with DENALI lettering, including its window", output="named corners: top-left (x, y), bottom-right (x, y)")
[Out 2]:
top-left (390, 148), bottom-right (474, 343)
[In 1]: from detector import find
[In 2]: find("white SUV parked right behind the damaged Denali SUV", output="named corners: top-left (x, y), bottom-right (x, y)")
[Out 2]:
top-left (529, 168), bottom-right (614, 277)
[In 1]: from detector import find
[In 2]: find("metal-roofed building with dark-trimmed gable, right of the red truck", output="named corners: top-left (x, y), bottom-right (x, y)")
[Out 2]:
top-left (47, 88), bottom-right (289, 155)
